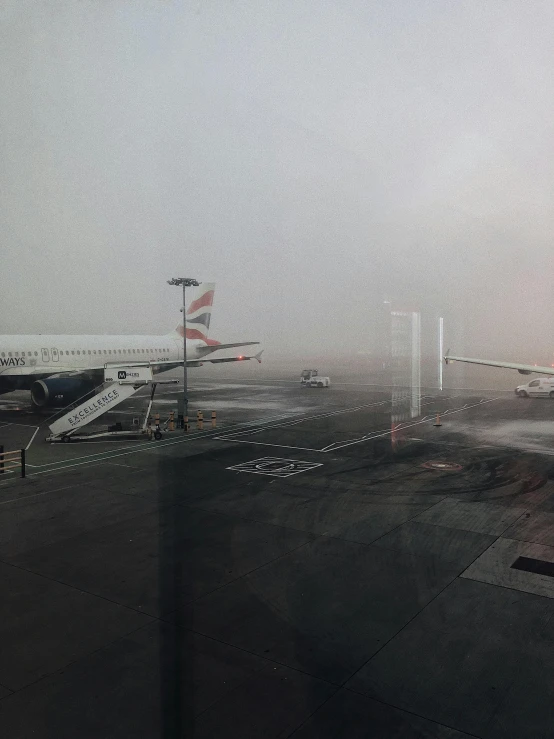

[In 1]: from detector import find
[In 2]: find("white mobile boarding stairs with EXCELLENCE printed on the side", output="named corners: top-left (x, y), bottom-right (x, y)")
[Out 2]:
top-left (46, 366), bottom-right (177, 442)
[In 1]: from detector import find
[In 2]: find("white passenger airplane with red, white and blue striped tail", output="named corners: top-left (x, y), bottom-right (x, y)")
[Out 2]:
top-left (0, 282), bottom-right (262, 408)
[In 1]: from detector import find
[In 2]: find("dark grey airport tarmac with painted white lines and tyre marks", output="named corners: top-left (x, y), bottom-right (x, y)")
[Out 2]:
top-left (0, 373), bottom-right (554, 739)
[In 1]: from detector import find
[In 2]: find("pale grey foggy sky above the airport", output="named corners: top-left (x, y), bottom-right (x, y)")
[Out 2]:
top-left (0, 0), bottom-right (554, 362)
